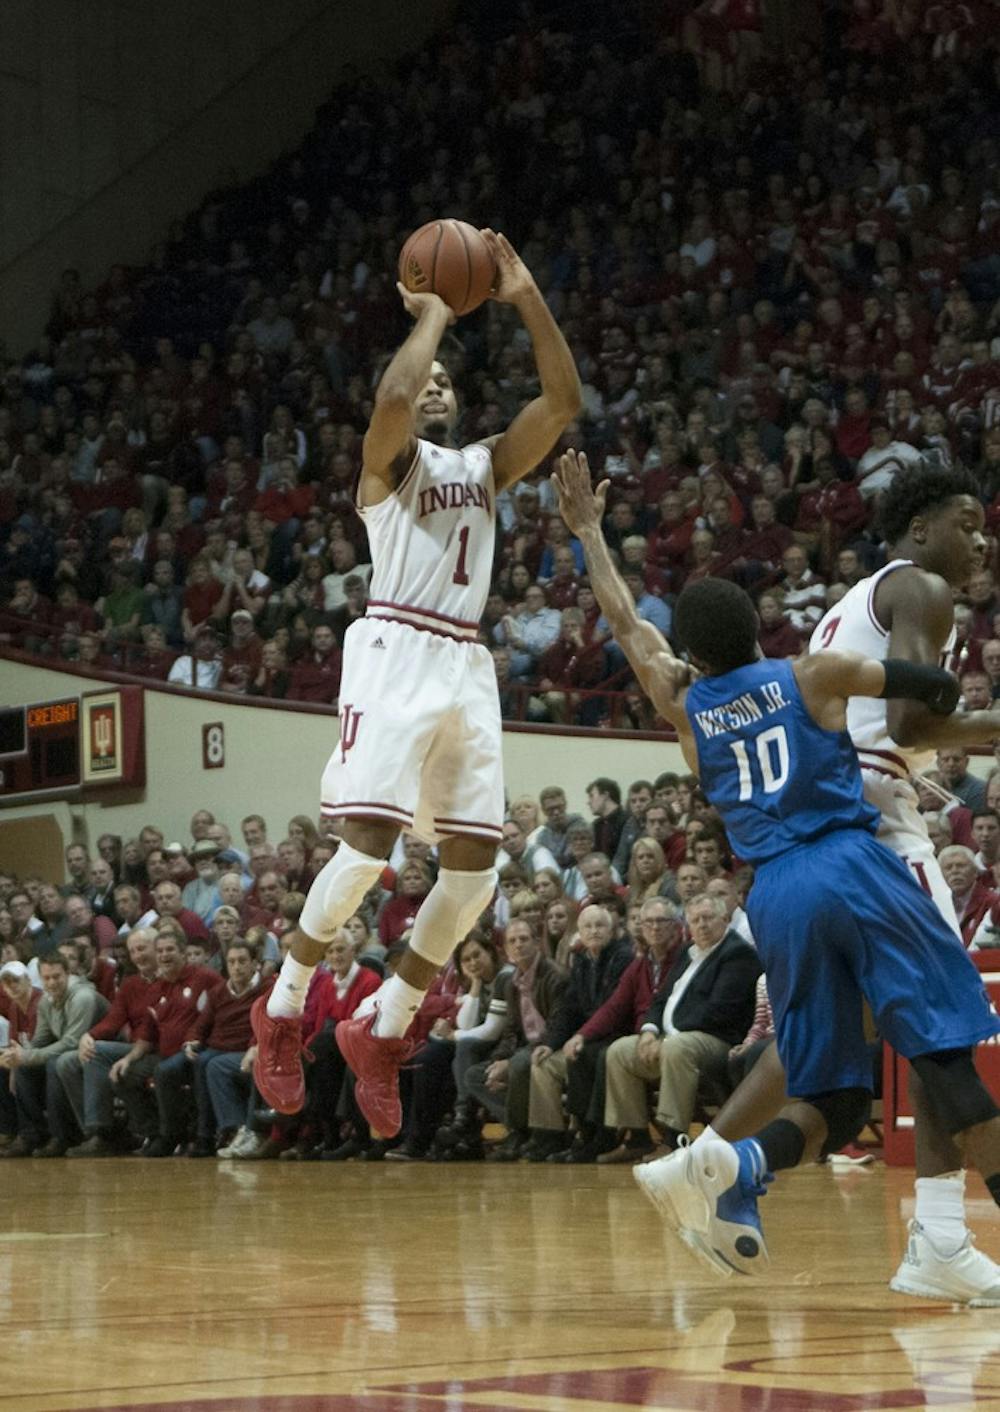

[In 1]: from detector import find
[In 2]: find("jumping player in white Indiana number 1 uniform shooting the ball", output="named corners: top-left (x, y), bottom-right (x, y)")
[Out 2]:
top-left (251, 230), bottom-right (581, 1137)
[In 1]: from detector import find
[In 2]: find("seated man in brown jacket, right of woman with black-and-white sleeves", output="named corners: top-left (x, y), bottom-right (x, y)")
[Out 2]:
top-left (466, 919), bottom-right (567, 1161)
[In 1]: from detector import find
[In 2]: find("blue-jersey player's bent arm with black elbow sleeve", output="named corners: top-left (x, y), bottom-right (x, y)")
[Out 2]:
top-left (792, 651), bottom-right (959, 730)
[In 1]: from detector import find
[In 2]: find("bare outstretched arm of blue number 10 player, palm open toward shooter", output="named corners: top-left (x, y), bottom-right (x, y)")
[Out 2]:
top-left (552, 450), bottom-right (691, 729)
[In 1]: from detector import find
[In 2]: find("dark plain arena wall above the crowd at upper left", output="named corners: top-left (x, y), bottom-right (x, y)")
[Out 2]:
top-left (0, 0), bottom-right (455, 353)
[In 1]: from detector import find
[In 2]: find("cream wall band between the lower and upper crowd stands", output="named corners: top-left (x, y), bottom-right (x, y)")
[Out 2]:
top-left (0, 659), bottom-right (685, 871)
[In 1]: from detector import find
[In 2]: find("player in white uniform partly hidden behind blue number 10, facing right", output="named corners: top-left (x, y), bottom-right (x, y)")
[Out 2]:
top-left (686, 462), bottom-right (1000, 1308)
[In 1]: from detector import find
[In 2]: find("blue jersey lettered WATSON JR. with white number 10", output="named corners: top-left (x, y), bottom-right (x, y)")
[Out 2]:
top-left (686, 659), bottom-right (879, 864)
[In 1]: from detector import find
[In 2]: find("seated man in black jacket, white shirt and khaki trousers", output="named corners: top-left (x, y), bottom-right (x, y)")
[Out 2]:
top-left (605, 894), bottom-right (761, 1159)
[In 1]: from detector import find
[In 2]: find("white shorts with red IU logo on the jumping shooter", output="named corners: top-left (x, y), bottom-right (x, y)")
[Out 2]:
top-left (322, 618), bottom-right (504, 843)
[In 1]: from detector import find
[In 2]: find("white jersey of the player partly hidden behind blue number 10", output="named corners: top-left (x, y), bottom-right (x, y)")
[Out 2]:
top-left (809, 559), bottom-right (955, 778)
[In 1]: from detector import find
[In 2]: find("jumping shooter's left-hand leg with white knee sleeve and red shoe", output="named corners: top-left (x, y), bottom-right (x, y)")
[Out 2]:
top-left (250, 819), bottom-right (400, 1113)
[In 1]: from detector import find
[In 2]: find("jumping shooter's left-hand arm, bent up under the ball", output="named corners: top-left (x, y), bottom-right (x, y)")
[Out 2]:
top-left (362, 284), bottom-right (455, 504)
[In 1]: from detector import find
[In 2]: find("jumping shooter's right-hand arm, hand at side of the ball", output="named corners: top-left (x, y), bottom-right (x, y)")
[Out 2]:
top-left (483, 230), bottom-right (583, 490)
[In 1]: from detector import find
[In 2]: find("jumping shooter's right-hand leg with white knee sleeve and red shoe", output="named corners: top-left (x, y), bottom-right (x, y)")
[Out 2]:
top-left (338, 836), bottom-right (496, 1137)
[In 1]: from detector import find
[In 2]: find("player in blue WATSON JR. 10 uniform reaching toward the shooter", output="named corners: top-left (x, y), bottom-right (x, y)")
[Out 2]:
top-left (556, 455), bottom-right (1000, 1272)
